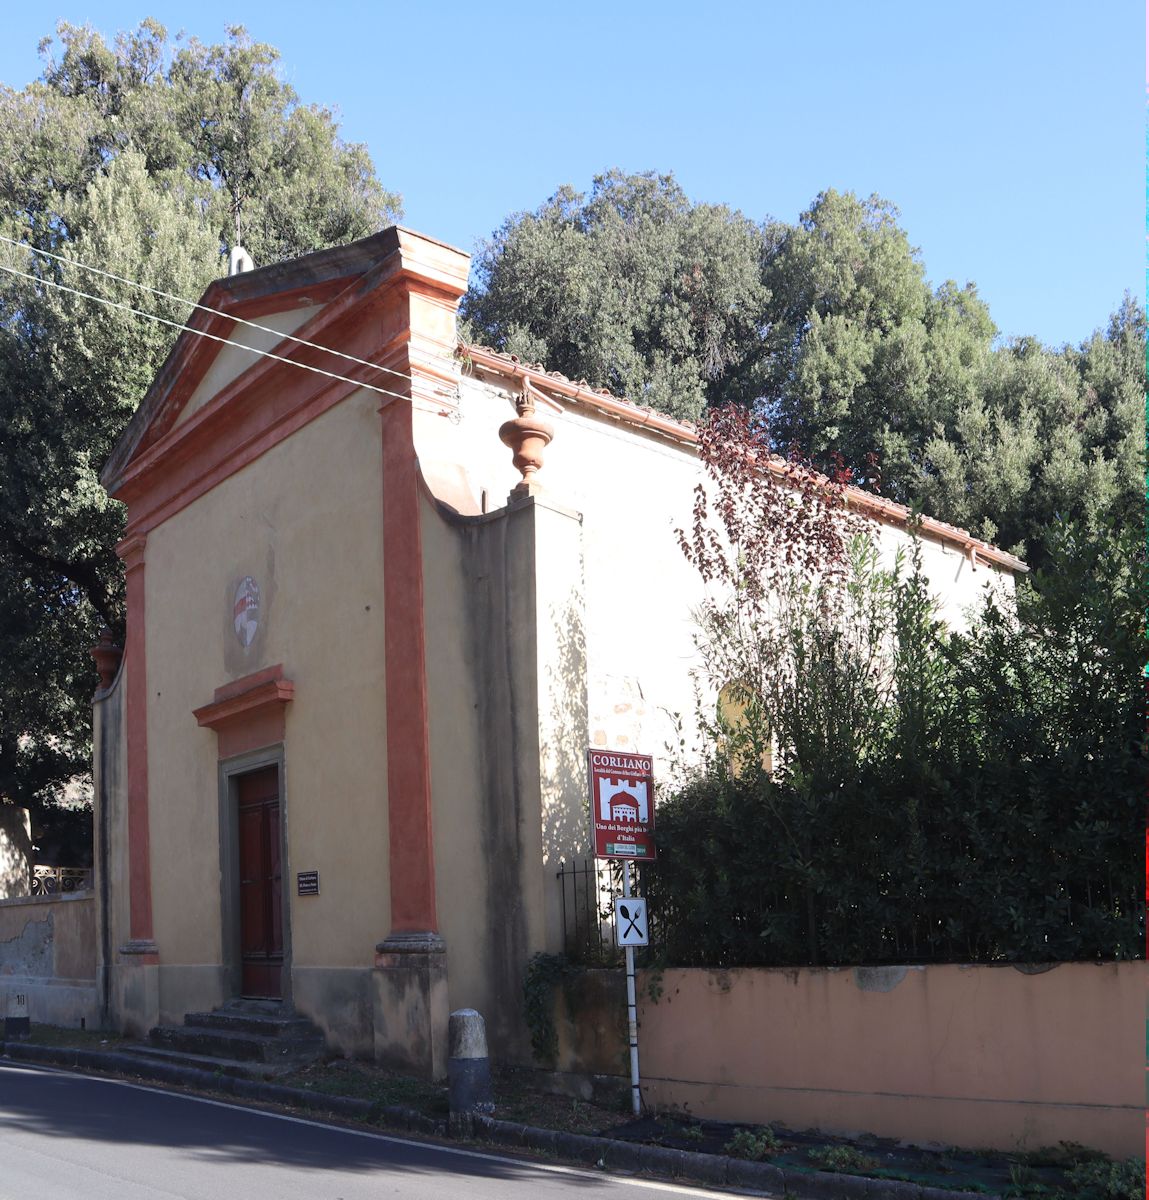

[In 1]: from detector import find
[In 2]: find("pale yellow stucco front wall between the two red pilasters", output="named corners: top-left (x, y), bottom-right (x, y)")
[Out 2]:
top-left (146, 392), bottom-right (389, 1020)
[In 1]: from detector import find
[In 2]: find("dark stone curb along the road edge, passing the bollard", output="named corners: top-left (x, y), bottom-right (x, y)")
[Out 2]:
top-left (0, 1042), bottom-right (993, 1200)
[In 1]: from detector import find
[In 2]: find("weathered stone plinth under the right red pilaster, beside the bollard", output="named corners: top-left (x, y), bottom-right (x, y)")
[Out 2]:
top-left (372, 934), bottom-right (450, 1080)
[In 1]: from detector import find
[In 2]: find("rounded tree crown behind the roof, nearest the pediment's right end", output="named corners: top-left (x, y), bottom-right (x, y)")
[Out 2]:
top-left (463, 172), bottom-right (768, 418)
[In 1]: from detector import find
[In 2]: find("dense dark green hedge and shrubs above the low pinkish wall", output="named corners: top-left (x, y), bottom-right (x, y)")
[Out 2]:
top-left (646, 527), bottom-right (1144, 966)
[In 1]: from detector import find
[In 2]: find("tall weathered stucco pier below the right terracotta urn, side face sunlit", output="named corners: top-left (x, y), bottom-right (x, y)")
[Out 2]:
top-left (461, 502), bottom-right (589, 1061)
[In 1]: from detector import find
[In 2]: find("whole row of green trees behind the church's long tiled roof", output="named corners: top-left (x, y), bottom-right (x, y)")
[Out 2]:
top-left (465, 172), bottom-right (1145, 563)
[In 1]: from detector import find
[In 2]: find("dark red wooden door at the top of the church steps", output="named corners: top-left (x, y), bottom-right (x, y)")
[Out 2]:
top-left (236, 767), bottom-right (283, 1000)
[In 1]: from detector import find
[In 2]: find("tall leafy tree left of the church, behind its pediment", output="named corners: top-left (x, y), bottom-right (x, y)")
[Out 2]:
top-left (0, 22), bottom-right (398, 805)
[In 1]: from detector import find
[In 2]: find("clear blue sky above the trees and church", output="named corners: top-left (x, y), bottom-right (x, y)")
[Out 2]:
top-left (0, 0), bottom-right (1145, 344)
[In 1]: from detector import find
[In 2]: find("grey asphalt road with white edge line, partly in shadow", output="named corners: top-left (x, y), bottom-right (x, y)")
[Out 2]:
top-left (0, 1063), bottom-right (734, 1200)
